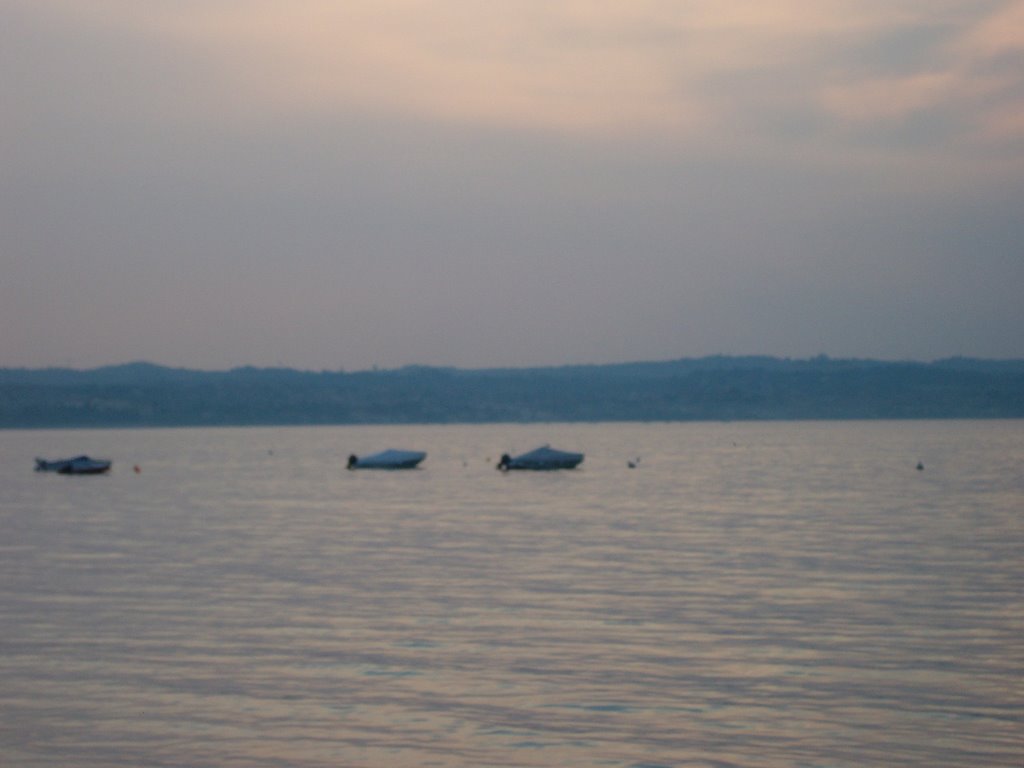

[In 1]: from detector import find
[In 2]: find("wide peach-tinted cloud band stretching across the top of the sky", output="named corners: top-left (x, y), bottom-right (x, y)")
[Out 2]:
top-left (6, 0), bottom-right (1024, 159)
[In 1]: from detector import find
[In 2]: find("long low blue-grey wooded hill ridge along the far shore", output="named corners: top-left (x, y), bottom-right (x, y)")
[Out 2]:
top-left (0, 356), bottom-right (1024, 429)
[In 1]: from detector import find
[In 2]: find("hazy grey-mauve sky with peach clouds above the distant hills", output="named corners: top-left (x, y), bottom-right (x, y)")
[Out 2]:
top-left (0, 0), bottom-right (1024, 371)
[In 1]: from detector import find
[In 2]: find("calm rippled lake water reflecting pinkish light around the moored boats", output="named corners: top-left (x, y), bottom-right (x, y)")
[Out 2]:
top-left (0, 421), bottom-right (1024, 768)
